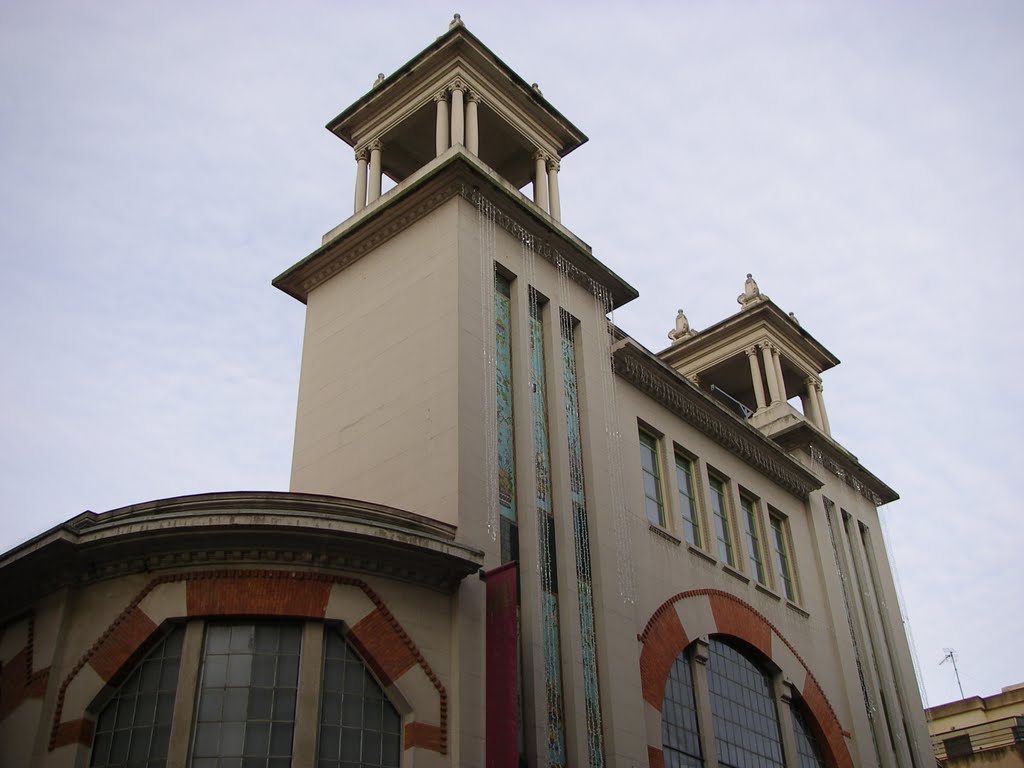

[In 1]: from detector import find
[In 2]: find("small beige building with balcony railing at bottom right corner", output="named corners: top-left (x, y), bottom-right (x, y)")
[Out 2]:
top-left (926, 683), bottom-right (1024, 768)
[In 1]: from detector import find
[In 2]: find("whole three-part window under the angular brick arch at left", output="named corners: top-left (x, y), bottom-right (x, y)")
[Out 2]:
top-left (90, 621), bottom-right (401, 768)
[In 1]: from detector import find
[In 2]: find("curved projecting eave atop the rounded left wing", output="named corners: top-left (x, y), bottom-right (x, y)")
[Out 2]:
top-left (0, 492), bottom-right (483, 620)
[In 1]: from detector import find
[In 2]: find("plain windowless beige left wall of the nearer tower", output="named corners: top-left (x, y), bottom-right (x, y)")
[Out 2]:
top-left (291, 201), bottom-right (459, 523)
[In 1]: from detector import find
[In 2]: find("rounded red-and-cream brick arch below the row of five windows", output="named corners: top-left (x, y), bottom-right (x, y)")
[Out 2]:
top-left (637, 590), bottom-right (853, 768)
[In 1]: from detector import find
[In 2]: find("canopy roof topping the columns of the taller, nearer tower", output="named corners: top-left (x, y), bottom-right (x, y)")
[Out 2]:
top-left (327, 16), bottom-right (587, 188)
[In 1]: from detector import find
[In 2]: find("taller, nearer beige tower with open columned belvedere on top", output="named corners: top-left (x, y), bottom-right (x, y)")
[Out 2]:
top-left (274, 17), bottom-right (638, 765)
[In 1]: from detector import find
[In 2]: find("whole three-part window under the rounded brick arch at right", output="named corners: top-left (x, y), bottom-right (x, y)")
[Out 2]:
top-left (662, 637), bottom-right (824, 768)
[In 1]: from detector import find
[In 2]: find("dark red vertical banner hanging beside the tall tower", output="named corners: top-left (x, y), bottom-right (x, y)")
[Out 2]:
top-left (483, 562), bottom-right (519, 768)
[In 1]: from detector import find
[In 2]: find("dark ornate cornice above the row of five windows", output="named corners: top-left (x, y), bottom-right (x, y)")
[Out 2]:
top-left (612, 340), bottom-right (822, 499)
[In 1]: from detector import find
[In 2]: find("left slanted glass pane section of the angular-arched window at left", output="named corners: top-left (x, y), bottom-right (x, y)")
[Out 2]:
top-left (89, 627), bottom-right (184, 768)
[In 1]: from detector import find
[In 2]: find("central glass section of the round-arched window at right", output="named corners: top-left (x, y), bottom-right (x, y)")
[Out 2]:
top-left (708, 638), bottom-right (784, 768)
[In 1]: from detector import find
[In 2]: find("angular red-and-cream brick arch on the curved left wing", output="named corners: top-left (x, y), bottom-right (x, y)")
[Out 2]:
top-left (49, 569), bottom-right (447, 755)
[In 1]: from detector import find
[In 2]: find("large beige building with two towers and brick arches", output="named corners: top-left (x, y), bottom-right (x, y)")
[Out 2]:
top-left (0, 18), bottom-right (932, 768)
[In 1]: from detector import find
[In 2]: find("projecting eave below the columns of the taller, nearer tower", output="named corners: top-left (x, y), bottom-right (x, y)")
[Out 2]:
top-left (272, 146), bottom-right (639, 308)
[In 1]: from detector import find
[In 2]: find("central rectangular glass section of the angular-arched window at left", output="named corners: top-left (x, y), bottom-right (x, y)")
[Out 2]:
top-left (191, 624), bottom-right (302, 768)
